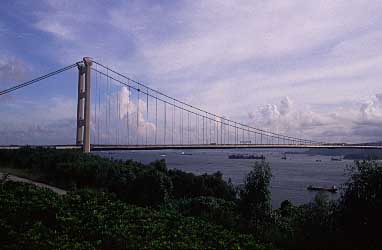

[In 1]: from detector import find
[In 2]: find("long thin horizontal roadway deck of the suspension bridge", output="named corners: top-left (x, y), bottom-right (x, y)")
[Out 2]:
top-left (0, 144), bottom-right (382, 151)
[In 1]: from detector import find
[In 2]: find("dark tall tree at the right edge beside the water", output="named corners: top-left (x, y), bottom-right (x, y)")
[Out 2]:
top-left (339, 161), bottom-right (382, 249)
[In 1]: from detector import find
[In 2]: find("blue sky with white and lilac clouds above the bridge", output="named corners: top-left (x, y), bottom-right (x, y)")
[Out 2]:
top-left (0, 0), bottom-right (382, 143)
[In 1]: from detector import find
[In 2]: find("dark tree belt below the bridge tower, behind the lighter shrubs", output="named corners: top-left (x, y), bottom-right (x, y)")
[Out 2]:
top-left (0, 147), bottom-right (235, 207)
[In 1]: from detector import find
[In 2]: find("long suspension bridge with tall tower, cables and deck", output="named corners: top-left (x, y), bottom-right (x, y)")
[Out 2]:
top-left (0, 57), bottom-right (382, 152)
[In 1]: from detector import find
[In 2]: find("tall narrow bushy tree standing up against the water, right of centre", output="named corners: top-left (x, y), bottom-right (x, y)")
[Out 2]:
top-left (239, 161), bottom-right (272, 236)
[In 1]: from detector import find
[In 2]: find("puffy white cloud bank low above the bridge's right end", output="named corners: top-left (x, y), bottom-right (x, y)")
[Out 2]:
top-left (248, 94), bottom-right (382, 142)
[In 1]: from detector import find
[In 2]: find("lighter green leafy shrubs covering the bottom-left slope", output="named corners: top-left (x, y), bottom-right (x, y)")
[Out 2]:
top-left (0, 182), bottom-right (270, 250)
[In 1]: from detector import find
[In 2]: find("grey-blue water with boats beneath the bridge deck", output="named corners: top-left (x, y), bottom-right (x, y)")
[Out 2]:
top-left (98, 149), bottom-right (353, 208)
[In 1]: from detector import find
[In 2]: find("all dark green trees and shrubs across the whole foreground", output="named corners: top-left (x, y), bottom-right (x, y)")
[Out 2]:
top-left (0, 148), bottom-right (382, 249)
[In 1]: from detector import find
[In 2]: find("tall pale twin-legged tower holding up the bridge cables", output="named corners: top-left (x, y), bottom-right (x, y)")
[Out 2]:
top-left (76, 57), bottom-right (92, 153)
